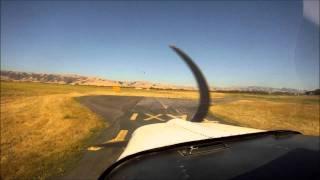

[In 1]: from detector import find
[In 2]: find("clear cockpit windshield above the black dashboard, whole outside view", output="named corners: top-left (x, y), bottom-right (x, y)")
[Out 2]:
top-left (0, 0), bottom-right (320, 180)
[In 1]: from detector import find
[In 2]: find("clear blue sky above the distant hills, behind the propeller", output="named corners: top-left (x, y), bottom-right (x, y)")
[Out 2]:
top-left (1, 1), bottom-right (319, 89)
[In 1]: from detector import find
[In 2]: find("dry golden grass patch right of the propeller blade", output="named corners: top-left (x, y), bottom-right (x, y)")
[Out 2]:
top-left (210, 94), bottom-right (320, 136)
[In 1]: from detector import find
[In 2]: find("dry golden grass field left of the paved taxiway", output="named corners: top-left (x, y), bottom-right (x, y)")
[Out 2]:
top-left (1, 83), bottom-right (105, 179)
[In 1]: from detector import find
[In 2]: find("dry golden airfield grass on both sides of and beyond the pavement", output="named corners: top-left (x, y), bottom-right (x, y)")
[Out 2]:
top-left (1, 81), bottom-right (320, 179)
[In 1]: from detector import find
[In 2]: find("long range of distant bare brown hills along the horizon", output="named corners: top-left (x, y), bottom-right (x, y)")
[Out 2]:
top-left (1, 71), bottom-right (312, 94)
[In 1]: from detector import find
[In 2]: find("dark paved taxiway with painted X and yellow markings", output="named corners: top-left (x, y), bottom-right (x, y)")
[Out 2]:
top-left (62, 96), bottom-right (226, 179)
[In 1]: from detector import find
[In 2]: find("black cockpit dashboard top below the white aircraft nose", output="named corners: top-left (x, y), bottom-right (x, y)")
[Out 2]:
top-left (101, 133), bottom-right (320, 180)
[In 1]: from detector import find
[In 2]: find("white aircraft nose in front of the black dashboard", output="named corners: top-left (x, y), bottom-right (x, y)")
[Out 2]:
top-left (118, 119), bottom-right (264, 160)
